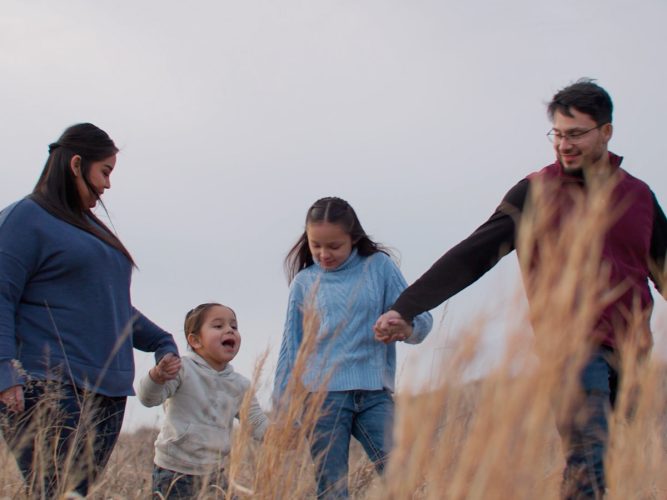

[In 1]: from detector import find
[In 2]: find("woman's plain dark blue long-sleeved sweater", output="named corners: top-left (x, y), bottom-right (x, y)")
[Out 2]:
top-left (0, 199), bottom-right (178, 396)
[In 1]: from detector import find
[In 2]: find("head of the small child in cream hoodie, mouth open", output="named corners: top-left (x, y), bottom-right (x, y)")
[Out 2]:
top-left (188, 306), bottom-right (241, 371)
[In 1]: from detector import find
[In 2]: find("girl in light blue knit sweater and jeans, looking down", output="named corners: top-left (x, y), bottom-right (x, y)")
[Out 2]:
top-left (273, 198), bottom-right (433, 498)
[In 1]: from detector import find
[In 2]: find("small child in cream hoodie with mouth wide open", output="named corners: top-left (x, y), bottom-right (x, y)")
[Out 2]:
top-left (137, 303), bottom-right (267, 499)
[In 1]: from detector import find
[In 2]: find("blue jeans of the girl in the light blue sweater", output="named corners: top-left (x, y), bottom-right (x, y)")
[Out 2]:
top-left (310, 390), bottom-right (394, 499)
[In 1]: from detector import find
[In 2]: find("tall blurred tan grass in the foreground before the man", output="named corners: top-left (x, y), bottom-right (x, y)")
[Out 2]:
top-left (378, 173), bottom-right (667, 500)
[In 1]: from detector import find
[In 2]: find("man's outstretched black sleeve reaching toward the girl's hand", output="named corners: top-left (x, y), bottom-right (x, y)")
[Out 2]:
top-left (391, 179), bottom-right (529, 321)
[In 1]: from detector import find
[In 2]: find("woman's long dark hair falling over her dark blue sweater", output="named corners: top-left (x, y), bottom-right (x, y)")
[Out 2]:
top-left (30, 123), bottom-right (134, 266)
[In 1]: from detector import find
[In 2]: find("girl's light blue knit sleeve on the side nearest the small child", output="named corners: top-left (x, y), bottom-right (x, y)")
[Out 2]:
top-left (271, 279), bottom-right (303, 409)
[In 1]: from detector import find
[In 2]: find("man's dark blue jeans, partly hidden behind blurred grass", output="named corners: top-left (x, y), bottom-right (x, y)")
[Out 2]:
top-left (558, 347), bottom-right (619, 500)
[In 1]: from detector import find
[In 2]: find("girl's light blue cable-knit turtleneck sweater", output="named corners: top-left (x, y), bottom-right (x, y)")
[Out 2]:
top-left (273, 249), bottom-right (433, 405)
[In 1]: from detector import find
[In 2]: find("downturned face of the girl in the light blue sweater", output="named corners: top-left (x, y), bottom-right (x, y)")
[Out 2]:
top-left (306, 222), bottom-right (352, 271)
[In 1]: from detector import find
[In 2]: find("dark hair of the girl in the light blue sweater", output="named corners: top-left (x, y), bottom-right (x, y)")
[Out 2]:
top-left (285, 196), bottom-right (390, 283)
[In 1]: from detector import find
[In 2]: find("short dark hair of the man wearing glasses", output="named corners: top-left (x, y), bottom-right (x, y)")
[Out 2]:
top-left (547, 78), bottom-right (614, 125)
